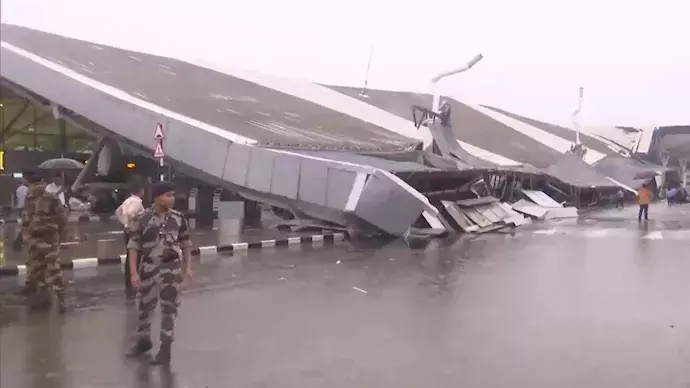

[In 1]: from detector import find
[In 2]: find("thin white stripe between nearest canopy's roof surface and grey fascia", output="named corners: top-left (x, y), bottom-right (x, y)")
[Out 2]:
top-left (0, 41), bottom-right (256, 144)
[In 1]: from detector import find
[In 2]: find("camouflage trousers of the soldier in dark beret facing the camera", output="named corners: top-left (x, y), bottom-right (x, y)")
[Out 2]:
top-left (137, 258), bottom-right (182, 343)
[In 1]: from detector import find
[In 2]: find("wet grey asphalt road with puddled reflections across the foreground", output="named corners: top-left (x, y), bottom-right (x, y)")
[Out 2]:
top-left (0, 207), bottom-right (690, 388)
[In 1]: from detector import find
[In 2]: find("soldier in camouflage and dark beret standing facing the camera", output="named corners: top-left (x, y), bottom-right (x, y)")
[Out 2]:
top-left (127, 182), bottom-right (192, 365)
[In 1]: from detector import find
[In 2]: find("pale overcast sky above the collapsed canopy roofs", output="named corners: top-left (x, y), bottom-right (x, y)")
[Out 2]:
top-left (2, 0), bottom-right (690, 125)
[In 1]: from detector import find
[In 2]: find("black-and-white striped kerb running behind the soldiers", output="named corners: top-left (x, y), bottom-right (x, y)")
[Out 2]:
top-left (0, 233), bottom-right (349, 277)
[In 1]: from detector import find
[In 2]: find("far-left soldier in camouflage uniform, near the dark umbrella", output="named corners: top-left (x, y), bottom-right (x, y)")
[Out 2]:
top-left (22, 174), bottom-right (67, 312)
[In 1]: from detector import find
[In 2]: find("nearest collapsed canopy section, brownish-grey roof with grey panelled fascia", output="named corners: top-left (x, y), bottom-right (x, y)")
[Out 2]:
top-left (0, 24), bottom-right (437, 235)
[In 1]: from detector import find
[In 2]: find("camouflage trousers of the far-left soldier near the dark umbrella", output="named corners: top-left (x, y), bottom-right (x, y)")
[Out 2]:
top-left (26, 239), bottom-right (65, 302)
